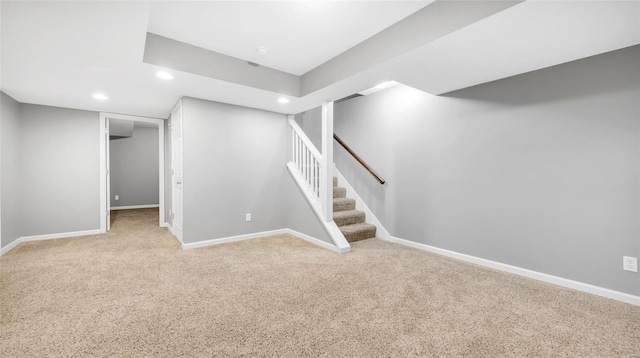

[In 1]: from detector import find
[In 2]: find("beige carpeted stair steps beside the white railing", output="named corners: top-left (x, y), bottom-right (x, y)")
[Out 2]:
top-left (333, 177), bottom-right (376, 242)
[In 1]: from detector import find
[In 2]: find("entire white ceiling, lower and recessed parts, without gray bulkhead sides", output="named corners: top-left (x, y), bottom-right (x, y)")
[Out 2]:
top-left (0, 1), bottom-right (640, 118)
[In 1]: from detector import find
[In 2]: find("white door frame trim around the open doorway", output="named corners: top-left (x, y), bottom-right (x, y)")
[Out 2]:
top-left (100, 112), bottom-right (165, 232)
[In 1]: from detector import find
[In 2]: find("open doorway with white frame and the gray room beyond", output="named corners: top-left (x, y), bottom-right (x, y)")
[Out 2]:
top-left (100, 113), bottom-right (165, 232)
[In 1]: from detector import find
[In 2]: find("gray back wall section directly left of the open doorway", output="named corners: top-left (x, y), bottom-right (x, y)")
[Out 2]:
top-left (20, 104), bottom-right (100, 236)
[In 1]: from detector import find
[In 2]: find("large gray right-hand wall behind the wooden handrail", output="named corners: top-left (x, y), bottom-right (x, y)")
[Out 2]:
top-left (335, 46), bottom-right (640, 295)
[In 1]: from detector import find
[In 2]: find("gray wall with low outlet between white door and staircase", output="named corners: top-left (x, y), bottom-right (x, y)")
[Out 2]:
top-left (183, 98), bottom-right (289, 243)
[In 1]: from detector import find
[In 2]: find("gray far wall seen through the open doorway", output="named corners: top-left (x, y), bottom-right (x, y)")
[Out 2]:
top-left (109, 122), bottom-right (160, 207)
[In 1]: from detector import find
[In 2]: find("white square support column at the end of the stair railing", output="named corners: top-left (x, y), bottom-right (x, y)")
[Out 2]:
top-left (320, 102), bottom-right (333, 222)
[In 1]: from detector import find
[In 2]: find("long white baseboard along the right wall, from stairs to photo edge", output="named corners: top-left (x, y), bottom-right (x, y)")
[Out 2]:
top-left (391, 236), bottom-right (640, 306)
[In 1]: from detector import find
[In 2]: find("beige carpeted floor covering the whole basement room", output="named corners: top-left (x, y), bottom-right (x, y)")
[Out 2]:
top-left (0, 209), bottom-right (640, 358)
